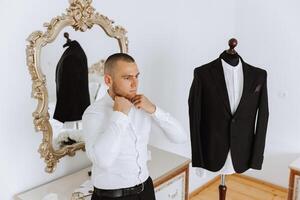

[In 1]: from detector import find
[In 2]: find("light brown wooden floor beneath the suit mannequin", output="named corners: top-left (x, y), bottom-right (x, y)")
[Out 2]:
top-left (190, 175), bottom-right (287, 200)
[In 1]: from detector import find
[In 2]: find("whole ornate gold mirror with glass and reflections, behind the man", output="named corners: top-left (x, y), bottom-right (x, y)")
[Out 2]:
top-left (26, 0), bottom-right (128, 173)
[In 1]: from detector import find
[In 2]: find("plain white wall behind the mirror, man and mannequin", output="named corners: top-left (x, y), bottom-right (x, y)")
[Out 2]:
top-left (0, 0), bottom-right (300, 199)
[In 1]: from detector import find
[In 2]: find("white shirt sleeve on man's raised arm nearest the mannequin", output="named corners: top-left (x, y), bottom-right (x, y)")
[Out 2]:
top-left (150, 106), bottom-right (187, 143)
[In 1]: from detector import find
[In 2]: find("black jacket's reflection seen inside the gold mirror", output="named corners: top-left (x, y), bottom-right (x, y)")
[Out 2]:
top-left (53, 40), bottom-right (90, 122)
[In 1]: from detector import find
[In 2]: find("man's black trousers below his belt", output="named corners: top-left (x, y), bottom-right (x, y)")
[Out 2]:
top-left (91, 176), bottom-right (155, 200)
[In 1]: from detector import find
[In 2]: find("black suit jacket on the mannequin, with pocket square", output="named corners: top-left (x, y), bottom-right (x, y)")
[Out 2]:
top-left (188, 55), bottom-right (269, 173)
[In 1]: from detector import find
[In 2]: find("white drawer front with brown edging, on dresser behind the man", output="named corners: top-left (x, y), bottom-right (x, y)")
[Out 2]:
top-left (154, 172), bottom-right (186, 200)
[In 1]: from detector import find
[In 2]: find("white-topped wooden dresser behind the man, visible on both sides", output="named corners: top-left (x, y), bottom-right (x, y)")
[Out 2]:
top-left (15, 145), bottom-right (190, 200)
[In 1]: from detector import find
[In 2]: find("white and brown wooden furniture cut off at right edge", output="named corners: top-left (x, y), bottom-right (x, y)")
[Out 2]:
top-left (288, 158), bottom-right (300, 200)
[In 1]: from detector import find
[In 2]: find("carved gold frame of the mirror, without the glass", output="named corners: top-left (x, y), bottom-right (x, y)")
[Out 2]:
top-left (26, 0), bottom-right (128, 173)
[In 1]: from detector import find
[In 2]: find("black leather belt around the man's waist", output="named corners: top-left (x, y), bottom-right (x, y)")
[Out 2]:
top-left (94, 179), bottom-right (148, 197)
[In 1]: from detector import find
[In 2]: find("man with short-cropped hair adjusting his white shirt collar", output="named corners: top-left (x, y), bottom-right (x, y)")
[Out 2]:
top-left (83, 53), bottom-right (187, 200)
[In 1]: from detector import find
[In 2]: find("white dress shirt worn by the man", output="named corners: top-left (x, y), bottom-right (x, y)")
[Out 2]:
top-left (83, 93), bottom-right (187, 189)
